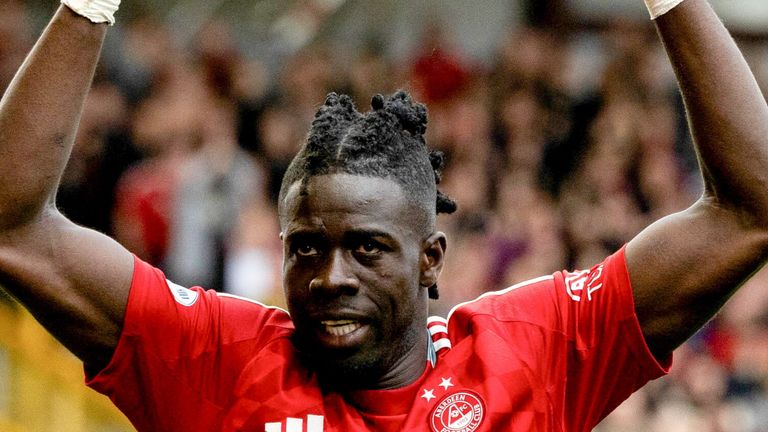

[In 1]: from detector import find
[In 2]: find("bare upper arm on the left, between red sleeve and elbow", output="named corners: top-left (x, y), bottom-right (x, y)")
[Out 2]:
top-left (0, 210), bottom-right (133, 368)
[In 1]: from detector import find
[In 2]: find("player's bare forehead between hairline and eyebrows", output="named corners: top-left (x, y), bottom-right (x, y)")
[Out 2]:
top-left (281, 174), bottom-right (420, 234)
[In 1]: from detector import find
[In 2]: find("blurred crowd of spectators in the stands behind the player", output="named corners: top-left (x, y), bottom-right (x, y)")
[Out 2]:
top-left (0, 2), bottom-right (768, 432)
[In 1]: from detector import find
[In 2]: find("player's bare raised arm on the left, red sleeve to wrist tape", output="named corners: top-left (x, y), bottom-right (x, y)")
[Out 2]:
top-left (0, 6), bottom-right (133, 370)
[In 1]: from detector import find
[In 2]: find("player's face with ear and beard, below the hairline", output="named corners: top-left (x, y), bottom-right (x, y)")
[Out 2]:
top-left (282, 174), bottom-right (445, 387)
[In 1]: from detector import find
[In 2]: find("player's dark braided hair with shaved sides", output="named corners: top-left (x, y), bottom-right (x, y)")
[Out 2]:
top-left (279, 90), bottom-right (456, 299)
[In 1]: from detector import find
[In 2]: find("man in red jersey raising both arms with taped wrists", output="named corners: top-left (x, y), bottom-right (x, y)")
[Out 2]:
top-left (0, 0), bottom-right (768, 432)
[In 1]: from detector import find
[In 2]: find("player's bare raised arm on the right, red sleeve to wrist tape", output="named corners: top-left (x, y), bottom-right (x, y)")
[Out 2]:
top-left (627, 0), bottom-right (768, 356)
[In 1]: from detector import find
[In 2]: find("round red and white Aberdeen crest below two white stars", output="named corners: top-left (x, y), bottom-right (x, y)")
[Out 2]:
top-left (429, 390), bottom-right (485, 432)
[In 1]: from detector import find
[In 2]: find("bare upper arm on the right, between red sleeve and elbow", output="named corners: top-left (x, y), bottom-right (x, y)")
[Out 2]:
top-left (626, 199), bottom-right (767, 358)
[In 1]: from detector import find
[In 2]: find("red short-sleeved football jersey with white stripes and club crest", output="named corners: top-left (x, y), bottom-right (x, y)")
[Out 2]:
top-left (88, 246), bottom-right (668, 432)
